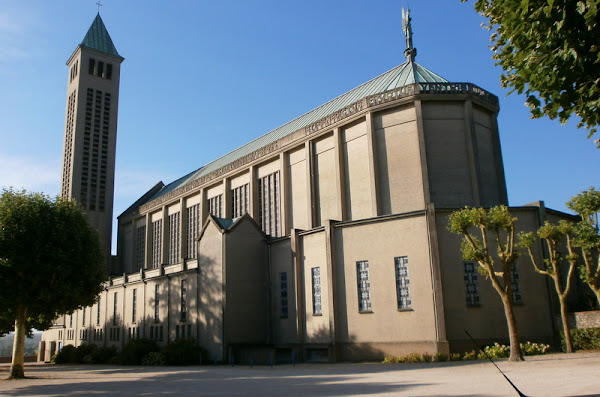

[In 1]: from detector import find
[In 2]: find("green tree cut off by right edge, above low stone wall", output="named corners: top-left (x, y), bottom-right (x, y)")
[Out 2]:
top-left (567, 187), bottom-right (600, 305)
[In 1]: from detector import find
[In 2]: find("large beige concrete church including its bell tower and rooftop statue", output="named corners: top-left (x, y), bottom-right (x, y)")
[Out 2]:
top-left (42, 10), bottom-right (572, 363)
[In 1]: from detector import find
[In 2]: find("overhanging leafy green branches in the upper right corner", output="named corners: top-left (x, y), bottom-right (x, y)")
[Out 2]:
top-left (461, 0), bottom-right (600, 147)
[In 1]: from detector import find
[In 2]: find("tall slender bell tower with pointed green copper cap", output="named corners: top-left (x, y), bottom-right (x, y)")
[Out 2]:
top-left (61, 13), bottom-right (124, 266)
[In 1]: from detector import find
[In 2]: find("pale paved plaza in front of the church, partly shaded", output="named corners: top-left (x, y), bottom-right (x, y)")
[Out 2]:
top-left (0, 352), bottom-right (600, 397)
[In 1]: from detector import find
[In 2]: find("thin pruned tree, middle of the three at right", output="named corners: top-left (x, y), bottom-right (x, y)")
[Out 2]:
top-left (517, 220), bottom-right (578, 353)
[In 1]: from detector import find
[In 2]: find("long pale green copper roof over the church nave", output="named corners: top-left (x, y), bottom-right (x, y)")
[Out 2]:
top-left (142, 61), bottom-right (448, 201)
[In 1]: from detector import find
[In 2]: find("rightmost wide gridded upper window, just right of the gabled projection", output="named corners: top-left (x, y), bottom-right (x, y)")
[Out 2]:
top-left (258, 171), bottom-right (281, 237)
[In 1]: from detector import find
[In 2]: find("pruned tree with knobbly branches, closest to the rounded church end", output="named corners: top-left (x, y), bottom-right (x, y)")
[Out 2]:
top-left (448, 205), bottom-right (523, 361)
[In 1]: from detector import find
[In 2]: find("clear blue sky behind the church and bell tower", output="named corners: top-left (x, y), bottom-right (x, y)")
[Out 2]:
top-left (0, 0), bottom-right (600, 254)
